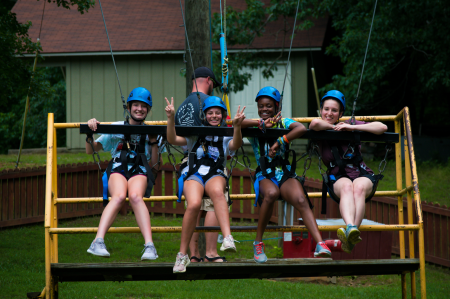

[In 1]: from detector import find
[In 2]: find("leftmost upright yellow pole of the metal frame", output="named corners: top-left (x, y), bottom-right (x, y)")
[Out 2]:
top-left (44, 113), bottom-right (54, 299)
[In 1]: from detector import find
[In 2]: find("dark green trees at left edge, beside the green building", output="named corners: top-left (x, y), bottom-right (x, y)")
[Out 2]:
top-left (0, 0), bottom-right (95, 153)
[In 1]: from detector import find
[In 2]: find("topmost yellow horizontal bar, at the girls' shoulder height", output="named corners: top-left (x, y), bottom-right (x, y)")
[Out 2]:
top-left (54, 115), bottom-right (403, 129)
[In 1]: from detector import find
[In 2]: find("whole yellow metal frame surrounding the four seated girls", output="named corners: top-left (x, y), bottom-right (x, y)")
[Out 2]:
top-left (41, 107), bottom-right (427, 299)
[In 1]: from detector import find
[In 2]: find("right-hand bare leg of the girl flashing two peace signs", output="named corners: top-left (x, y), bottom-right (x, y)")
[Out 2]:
top-left (205, 176), bottom-right (231, 237)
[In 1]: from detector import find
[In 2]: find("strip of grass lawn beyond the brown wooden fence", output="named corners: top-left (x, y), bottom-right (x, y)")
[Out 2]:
top-left (0, 150), bottom-right (450, 207)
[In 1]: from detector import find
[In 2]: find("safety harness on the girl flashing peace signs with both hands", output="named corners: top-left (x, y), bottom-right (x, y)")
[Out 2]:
top-left (177, 136), bottom-right (232, 205)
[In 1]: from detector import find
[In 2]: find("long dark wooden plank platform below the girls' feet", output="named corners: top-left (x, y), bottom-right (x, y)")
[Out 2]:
top-left (51, 259), bottom-right (419, 282)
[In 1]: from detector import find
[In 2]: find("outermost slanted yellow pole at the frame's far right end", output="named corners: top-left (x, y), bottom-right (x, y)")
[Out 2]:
top-left (403, 107), bottom-right (427, 299)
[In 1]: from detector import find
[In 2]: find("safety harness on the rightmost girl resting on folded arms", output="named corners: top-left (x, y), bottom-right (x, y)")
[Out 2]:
top-left (319, 139), bottom-right (384, 214)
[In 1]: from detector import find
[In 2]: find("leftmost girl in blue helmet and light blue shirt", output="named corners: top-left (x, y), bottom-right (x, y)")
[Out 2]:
top-left (86, 87), bottom-right (160, 260)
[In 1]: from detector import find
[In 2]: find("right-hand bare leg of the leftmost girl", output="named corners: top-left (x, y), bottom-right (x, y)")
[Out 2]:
top-left (128, 175), bottom-right (153, 244)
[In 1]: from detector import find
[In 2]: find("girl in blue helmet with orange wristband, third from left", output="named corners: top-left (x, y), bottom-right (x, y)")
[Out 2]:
top-left (242, 86), bottom-right (331, 263)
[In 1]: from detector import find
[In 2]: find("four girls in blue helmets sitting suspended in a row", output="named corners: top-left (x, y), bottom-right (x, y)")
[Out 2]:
top-left (86, 87), bottom-right (387, 273)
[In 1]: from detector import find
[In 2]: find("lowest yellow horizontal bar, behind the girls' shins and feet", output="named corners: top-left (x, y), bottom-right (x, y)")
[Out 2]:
top-left (50, 224), bottom-right (419, 234)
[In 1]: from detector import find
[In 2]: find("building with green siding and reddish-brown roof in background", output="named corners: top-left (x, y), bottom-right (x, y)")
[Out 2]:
top-left (13, 0), bottom-right (327, 148)
